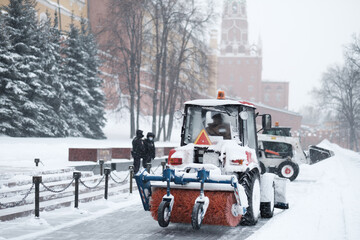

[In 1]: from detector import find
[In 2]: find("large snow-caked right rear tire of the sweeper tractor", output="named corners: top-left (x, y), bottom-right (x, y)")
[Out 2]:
top-left (240, 172), bottom-right (260, 226)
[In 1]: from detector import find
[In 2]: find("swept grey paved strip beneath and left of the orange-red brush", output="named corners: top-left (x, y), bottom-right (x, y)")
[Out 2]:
top-left (32, 203), bottom-right (266, 240)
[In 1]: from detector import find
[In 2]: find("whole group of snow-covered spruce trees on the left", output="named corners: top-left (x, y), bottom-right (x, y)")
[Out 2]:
top-left (0, 0), bottom-right (105, 138)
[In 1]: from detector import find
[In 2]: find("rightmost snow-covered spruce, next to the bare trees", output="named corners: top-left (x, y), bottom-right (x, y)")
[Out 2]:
top-left (61, 18), bottom-right (105, 138)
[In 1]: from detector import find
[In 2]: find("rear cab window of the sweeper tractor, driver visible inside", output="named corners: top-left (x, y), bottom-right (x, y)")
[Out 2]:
top-left (183, 106), bottom-right (239, 144)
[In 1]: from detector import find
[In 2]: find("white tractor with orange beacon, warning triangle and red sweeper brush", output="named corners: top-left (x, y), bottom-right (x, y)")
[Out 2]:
top-left (135, 91), bottom-right (288, 229)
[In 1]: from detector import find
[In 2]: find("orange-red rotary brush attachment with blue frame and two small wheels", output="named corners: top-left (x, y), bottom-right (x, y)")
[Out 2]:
top-left (136, 168), bottom-right (248, 229)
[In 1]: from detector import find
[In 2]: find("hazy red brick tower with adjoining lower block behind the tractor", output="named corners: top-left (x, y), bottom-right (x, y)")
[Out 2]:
top-left (217, 0), bottom-right (289, 109)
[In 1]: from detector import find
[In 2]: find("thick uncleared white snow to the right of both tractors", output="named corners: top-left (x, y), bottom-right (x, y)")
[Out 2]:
top-left (249, 140), bottom-right (360, 240)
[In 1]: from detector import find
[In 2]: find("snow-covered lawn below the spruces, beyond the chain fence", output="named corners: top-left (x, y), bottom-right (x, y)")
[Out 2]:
top-left (0, 113), bottom-right (180, 173)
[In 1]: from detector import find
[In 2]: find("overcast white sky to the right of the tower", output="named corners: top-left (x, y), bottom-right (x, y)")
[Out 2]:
top-left (212, 0), bottom-right (360, 111)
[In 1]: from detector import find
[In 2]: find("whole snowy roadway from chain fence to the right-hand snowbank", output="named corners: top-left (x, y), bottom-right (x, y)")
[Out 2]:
top-left (0, 140), bottom-right (360, 240)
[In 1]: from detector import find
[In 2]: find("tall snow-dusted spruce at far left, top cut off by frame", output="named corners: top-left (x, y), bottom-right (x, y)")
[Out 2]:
top-left (2, 0), bottom-right (50, 136)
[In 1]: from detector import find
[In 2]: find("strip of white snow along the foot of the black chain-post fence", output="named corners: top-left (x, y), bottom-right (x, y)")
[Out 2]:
top-left (0, 192), bottom-right (141, 240)
